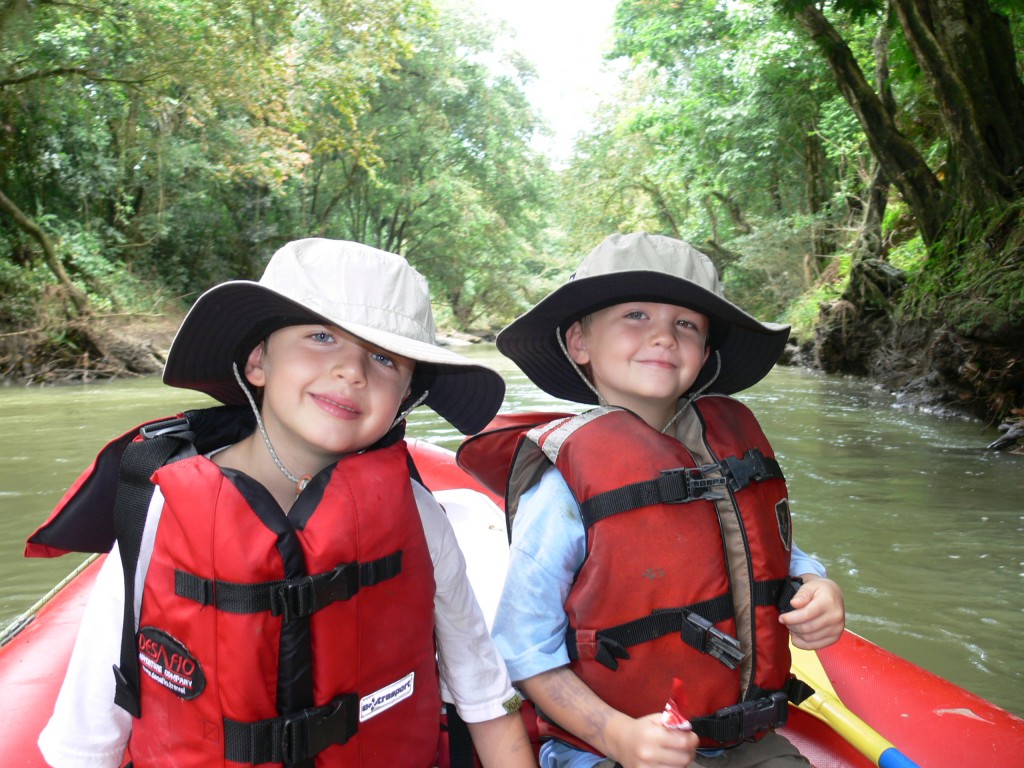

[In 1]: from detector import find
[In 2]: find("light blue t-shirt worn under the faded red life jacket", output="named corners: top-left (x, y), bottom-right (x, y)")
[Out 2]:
top-left (492, 467), bottom-right (825, 768)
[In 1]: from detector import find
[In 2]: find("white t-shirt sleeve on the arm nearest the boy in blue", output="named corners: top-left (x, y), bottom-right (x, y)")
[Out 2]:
top-left (413, 482), bottom-right (516, 723)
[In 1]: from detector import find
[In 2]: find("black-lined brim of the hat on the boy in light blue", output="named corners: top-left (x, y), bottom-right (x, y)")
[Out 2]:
top-left (497, 270), bottom-right (790, 404)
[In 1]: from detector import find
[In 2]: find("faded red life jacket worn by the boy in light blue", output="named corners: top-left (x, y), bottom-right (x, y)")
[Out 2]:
top-left (459, 395), bottom-right (794, 751)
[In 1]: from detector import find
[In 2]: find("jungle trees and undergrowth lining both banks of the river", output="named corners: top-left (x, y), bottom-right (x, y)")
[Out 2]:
top-left (0, 0), bottom-right (1024, 430)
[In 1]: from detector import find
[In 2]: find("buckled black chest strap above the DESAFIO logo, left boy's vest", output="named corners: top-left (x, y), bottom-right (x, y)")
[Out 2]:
top-left (174, 550), bottom-right (401, 622)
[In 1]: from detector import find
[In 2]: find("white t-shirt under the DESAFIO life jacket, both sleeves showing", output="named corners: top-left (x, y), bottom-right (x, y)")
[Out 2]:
top-left (39, 481), bottom-right (515, 768)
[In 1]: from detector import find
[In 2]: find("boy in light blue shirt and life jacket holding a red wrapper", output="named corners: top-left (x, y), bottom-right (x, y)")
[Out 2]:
top-left (483, 232), bottom-right (845, 768)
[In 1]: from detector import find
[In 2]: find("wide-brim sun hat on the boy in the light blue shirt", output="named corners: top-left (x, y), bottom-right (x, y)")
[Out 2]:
top-left (498, 232), bottom-right (790, 404)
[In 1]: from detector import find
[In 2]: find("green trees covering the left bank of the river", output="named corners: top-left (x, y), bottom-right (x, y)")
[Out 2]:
top-left (0, 0), bottom-right (548, 335)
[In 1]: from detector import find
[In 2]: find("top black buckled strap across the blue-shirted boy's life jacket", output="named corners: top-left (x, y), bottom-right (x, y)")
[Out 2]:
top-left (580, 447), bottom-right (785, 527)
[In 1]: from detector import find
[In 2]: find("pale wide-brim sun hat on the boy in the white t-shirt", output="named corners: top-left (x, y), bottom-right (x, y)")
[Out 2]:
top-left (164, 238), bottom-right (505, 434)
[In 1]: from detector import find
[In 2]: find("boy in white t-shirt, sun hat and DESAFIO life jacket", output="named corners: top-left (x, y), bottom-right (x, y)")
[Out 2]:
top-left (39, 238), bottom-right (536, 768)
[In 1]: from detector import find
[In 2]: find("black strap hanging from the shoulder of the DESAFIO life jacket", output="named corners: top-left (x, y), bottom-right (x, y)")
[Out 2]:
top-left (114, 419), bottom-right (196, 718)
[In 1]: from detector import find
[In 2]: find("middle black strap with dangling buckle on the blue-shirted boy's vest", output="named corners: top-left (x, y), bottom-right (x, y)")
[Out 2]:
top-left (565, 595), bottom-right (743, 670)
